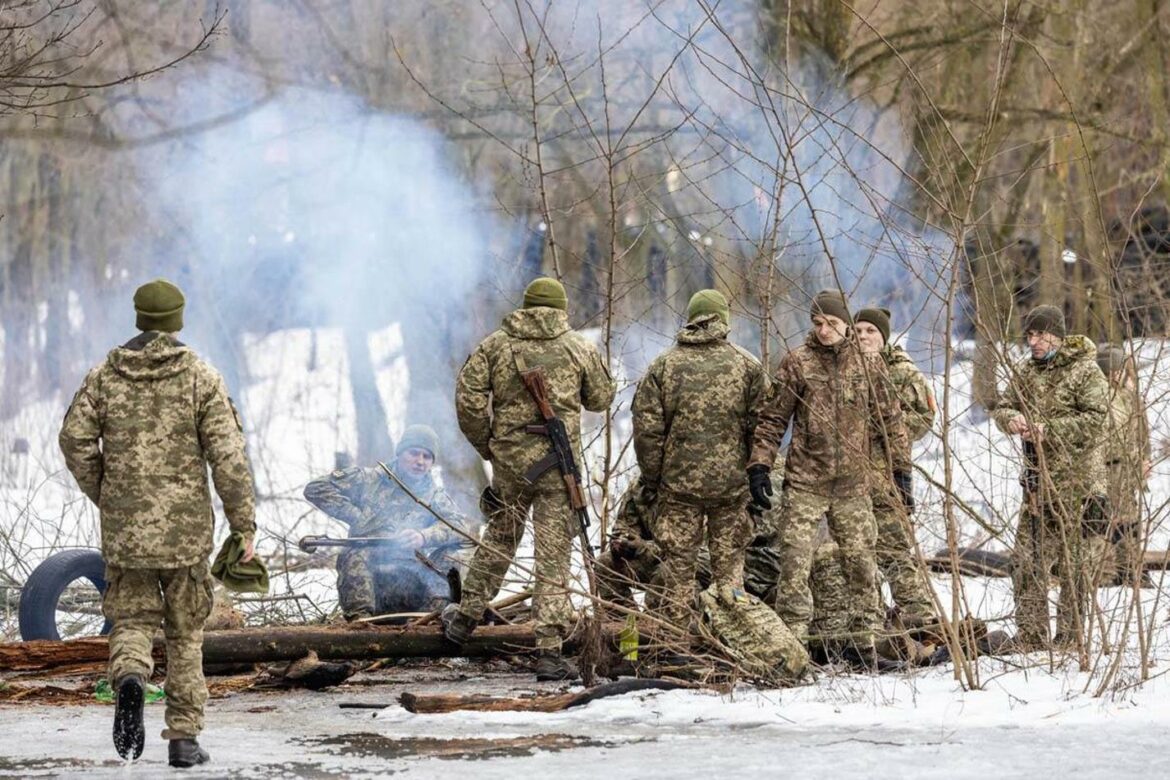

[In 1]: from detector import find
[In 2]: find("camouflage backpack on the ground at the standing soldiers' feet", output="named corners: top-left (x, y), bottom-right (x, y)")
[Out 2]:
top-left (698, 585), bottom-right (808, 682)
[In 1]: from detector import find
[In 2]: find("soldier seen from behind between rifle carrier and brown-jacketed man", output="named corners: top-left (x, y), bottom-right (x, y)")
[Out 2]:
top-left (632, 290), bottom-right (769, 630)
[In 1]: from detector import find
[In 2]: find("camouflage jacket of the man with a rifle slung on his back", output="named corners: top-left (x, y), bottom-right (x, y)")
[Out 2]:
top-left (455, 306), bottom-right (615, 484)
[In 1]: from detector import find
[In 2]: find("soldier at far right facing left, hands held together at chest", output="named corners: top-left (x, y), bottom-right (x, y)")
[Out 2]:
top-left (992, 306), bottom-right (1109, 650)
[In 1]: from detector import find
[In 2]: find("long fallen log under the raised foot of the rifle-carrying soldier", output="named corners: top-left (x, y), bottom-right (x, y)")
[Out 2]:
top-left (0, 623), bottom-right (621, 671)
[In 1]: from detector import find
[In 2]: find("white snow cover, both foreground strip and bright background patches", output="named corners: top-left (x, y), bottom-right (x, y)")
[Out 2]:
top-left (0, 329), bottom-right (1170, 778)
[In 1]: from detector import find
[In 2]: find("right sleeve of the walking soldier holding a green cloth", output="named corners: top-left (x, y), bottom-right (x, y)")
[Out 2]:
top-left (198, 375), bottom-right (256, 536)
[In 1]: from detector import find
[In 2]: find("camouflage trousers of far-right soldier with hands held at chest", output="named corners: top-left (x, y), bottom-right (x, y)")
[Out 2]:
top-left (1012, 501), bottom-right (1106, 647)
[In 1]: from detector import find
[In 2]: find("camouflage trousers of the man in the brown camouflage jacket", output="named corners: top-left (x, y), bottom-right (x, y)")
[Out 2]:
top-left (776, 488), bottom-right (881, 646)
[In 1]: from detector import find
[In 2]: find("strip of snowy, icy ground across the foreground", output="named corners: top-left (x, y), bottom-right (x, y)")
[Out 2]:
top-left (0, 660), bottom-right (1170, 780)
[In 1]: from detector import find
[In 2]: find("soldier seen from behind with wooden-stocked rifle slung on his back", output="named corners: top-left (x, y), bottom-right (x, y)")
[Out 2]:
top-left (443, 278), bottom-right (615, 679)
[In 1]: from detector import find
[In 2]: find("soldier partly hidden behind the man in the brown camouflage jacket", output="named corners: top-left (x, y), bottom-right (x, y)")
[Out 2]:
top-left (854, 308), bottom-right (935, 622)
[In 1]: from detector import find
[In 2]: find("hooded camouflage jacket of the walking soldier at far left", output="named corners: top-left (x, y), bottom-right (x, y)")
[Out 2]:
top-left (59, 332), bottom-right (256, 568)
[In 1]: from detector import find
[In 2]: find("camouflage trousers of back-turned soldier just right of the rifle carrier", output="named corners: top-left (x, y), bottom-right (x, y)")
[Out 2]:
top-left (654, 495), bottom-right (751, 631)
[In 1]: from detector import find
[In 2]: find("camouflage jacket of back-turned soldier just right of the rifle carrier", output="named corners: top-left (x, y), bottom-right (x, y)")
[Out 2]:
top-left (633, 315), bottom-right (769, 501)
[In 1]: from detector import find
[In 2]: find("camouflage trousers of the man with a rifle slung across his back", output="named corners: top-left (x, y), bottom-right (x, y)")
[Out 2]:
top-left (459, 469), bottom-right (577, 651)
